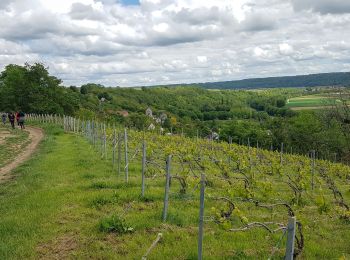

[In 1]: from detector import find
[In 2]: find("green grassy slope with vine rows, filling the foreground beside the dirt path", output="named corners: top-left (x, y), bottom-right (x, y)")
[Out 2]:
top-left (0, 121), bottom-right (350, 259)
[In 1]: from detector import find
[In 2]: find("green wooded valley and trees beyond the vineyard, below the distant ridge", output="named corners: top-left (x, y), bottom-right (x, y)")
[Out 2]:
top-left (0, 63), bottom-right (350, 161)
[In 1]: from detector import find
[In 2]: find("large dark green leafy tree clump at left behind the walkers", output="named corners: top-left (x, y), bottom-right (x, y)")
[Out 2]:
top-left (0, 63), bottom-right (79, 114)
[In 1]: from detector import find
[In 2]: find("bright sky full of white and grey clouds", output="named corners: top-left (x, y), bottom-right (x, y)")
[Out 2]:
top-left (0, 0), bottom-right (350, 87)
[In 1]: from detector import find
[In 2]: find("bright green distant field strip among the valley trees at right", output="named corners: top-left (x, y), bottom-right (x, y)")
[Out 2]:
top-left (286, 95), bottom-right (341, 110)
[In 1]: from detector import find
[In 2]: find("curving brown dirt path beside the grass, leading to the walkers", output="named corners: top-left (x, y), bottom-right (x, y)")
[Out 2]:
top-left (0, 127), bottom-right (44, 183)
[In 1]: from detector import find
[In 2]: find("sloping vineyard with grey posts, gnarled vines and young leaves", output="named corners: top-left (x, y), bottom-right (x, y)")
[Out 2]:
top-left (0, 115), bottom-right (350, 259)
